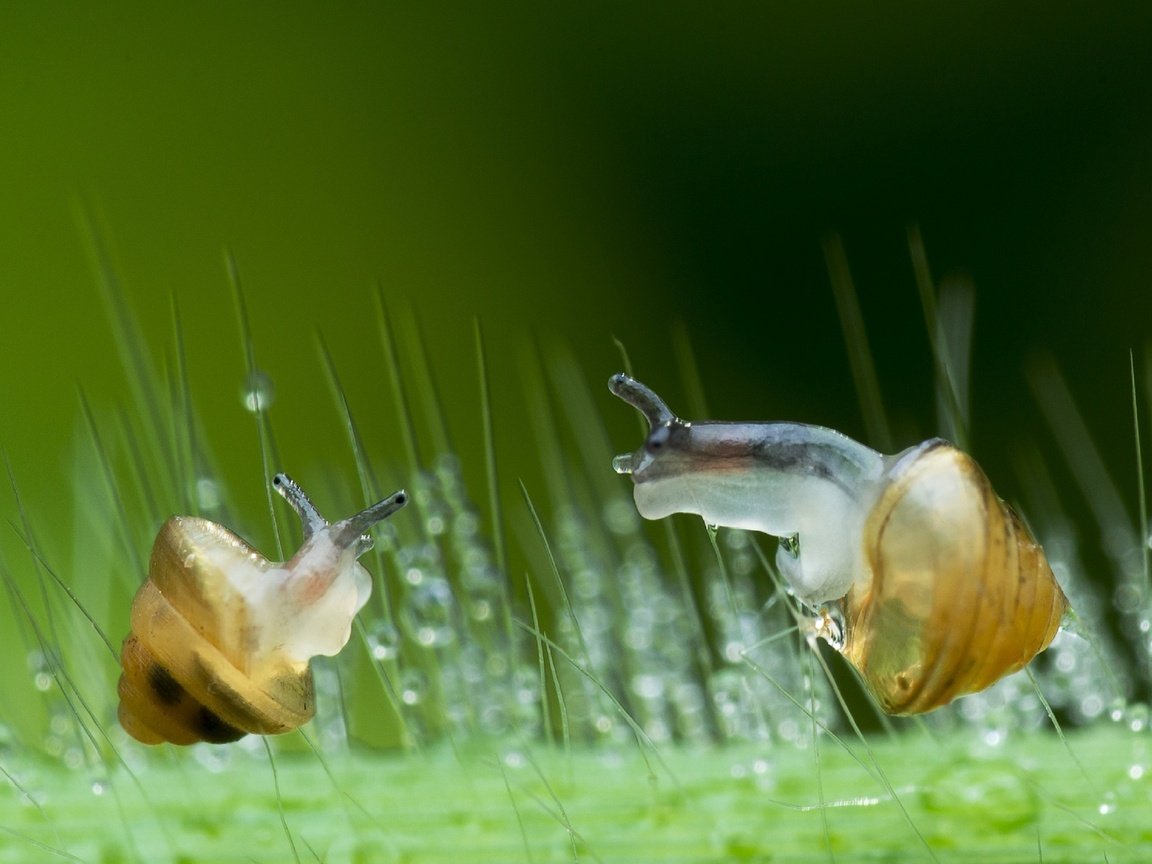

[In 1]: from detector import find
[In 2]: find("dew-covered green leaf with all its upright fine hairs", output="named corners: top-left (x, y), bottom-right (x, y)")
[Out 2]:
top-left (0, 231), bottom-right (1152, 862)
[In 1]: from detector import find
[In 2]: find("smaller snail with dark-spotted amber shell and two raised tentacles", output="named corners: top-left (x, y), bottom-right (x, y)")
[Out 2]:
top-left (118, 473), bottom-right (408, 744)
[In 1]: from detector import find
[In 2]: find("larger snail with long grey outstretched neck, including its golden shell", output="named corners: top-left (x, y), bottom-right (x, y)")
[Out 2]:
top-left (608, 373), bottom-right (1068, 714)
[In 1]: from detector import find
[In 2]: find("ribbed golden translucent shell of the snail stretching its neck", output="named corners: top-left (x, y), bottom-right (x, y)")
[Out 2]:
top-left (842, 439), bottom-right (1068, 714)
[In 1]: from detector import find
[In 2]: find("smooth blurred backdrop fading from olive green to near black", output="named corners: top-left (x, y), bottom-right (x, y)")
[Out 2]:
top-left (0, 1), bottom-right (1152, 594)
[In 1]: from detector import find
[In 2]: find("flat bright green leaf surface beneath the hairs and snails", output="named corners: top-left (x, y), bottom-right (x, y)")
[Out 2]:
top-left (0, 723), bottom-right (1152, 864)
